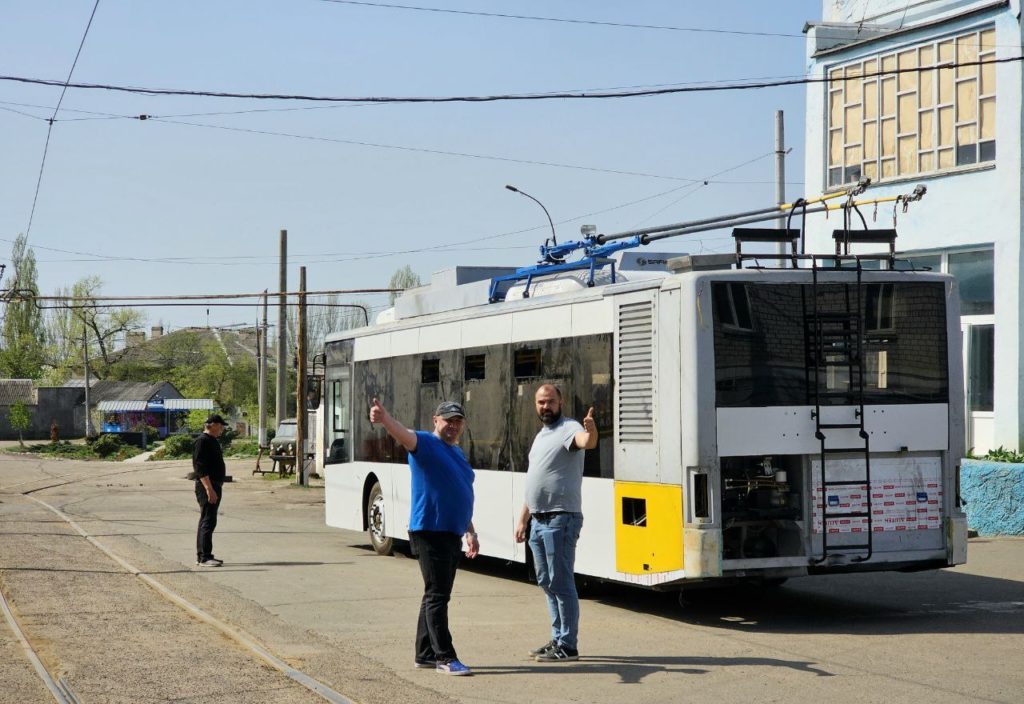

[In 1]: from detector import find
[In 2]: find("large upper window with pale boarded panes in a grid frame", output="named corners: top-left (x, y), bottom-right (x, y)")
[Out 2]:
top-left (825, 28), bottom-right (996, 187)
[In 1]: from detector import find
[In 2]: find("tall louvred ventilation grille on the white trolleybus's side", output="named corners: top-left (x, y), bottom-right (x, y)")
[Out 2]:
top-left (616, 301), bottom-right (654, 442)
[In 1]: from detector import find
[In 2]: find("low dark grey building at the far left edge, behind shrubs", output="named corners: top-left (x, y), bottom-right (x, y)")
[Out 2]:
top-left (0, 379), bottom-right (85, 440)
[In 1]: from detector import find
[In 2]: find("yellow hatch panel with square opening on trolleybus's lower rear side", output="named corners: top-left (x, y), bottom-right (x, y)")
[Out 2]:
top-left (615, 482), bottom-right (683, 574)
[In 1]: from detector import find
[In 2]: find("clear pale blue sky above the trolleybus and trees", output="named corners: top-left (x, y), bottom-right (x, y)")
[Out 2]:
top-left (0, 0), bottom-right (821, 328)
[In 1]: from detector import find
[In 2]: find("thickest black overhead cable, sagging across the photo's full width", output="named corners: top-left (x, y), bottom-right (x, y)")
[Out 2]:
top-left (0, 56), bottom-right (1024, 104)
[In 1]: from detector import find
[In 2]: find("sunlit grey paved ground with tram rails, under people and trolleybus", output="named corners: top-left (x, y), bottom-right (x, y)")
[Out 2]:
top-left (0, 455), bottom-right (1024, 704)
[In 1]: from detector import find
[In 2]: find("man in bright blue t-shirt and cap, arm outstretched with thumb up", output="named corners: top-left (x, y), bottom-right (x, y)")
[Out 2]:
top-left (370, 398), bottom-right (480, 674)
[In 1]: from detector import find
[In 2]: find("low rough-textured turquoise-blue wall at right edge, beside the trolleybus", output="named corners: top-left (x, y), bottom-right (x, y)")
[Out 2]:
top-left (961, 459), bottom-right (1024, 535)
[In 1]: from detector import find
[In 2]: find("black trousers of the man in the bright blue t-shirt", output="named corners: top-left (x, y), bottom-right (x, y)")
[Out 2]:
top-left (409, 530), bottom-right (462, 662)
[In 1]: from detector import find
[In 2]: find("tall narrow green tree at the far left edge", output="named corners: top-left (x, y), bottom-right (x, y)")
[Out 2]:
top-left (0, 234), bottom-right (46, 379)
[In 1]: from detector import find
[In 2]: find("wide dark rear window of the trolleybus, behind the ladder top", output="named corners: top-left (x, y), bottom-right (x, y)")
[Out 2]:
top-left (712, 281), bottom-right (949, 407)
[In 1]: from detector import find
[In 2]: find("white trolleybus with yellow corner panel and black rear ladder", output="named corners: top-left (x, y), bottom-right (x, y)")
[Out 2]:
top-left (318, 187), bottom-right (967, 589)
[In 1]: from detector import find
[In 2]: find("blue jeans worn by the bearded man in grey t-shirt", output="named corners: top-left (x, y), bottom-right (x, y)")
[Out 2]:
top-left (529, 513), bottom-right (583, 650)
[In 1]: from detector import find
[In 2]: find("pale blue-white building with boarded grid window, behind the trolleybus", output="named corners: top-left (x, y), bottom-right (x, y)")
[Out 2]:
top-left (805, 0), bottom-right (1003, 453)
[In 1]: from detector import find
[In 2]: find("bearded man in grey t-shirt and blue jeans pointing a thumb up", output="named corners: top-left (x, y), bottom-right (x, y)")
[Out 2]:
top-left (515, 384), bottom-right (597, 662)
